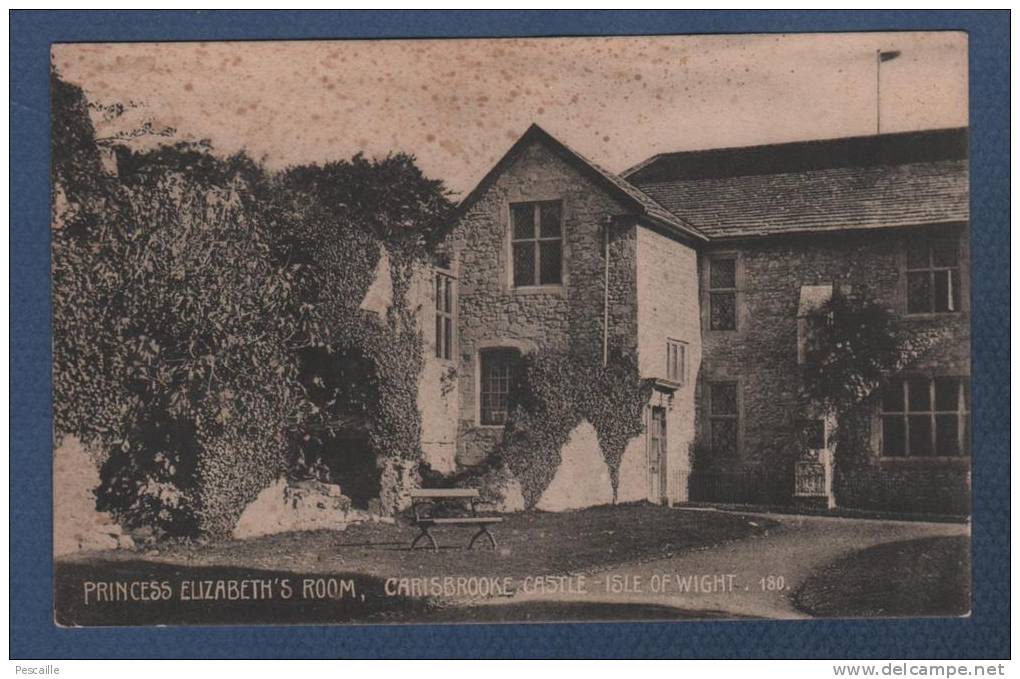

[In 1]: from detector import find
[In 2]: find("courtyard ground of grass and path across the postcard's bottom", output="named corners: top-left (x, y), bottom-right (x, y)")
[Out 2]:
top-left (56, 505), bottom-right (969, 625)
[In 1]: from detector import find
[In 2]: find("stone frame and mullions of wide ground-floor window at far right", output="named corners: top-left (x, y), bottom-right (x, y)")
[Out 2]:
top-left (872, 372), bottom-right (973, 464)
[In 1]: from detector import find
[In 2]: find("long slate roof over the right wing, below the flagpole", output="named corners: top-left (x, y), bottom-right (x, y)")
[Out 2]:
top-left (624, 129), bottom-right (970, 240)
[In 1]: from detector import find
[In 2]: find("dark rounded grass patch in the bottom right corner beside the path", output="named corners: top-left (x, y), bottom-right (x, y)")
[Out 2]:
top-left (795, 536), bottom-right (970, 618)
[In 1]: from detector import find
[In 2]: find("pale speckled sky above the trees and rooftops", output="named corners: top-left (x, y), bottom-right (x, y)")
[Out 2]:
top-left (52, 32), bottom-right (967, 196)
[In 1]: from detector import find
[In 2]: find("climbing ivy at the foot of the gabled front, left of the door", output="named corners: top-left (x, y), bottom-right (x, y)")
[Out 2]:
top-left (496, 351), bottom-right (652, 506)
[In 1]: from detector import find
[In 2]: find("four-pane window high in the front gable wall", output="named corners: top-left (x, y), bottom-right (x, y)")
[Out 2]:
top-left (510, 201), bottom-right (563, 288)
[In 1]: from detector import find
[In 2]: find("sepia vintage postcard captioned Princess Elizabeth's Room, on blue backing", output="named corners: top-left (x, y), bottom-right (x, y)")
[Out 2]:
top-left (51, 32), bottom-right (971, 627)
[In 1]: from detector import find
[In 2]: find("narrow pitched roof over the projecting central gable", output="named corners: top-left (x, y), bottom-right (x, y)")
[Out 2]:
top-left (454, 124), bottom-right (706, 241)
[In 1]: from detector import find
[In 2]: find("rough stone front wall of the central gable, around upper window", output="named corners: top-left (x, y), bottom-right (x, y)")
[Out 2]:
top-left (448, 137), bottom-right (636, 466)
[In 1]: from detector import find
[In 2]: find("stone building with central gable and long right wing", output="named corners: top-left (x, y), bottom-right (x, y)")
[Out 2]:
top-left (419, 125), bottom-right (970, 513)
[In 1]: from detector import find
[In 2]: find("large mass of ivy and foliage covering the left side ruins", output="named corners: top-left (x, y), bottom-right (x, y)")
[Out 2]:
top-left (52, 69), bottom-right (450, 534)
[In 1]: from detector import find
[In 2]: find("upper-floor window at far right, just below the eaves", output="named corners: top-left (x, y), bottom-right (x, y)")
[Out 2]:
top-left (907, 228), bottom-right (960, 314)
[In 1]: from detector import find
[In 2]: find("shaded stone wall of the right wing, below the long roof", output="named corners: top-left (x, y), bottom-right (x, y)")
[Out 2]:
top-left (694, 224), bottom-right (970, 513)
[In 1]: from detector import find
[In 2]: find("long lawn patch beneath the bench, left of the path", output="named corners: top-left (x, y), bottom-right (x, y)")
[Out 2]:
top-left (127, 504), bottom-right (775, 578)
